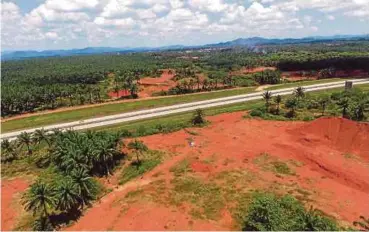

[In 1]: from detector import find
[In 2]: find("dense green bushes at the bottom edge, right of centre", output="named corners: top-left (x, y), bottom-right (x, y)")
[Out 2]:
top-left (243, 193), bottom-right (339, 231)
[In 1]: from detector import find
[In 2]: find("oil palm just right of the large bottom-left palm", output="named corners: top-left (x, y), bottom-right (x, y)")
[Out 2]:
top-left (55, 178), bottom-right (82, 212)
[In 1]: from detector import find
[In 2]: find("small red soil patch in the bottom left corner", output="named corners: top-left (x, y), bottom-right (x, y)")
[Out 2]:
top-left (1, 178), bottom-right (29, 231)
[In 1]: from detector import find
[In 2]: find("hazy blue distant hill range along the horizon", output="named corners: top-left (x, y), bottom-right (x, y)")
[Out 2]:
top-left (1, 34), bottom-right (369, 60)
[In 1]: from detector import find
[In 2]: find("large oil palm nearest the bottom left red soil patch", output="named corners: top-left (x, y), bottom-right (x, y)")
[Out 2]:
top-left (22, 181), bottom-right (56, 217)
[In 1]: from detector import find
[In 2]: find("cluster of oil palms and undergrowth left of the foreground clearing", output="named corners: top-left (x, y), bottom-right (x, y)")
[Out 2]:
top-left (2, 130), bottom-right (124, 230)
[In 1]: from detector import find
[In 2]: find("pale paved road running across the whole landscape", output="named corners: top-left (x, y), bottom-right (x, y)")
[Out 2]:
top-left (1, 79), bottom-right (369, 140)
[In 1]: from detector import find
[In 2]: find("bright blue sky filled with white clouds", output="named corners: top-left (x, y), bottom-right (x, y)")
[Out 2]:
top-left (1, 0), bottom-right (369, 51)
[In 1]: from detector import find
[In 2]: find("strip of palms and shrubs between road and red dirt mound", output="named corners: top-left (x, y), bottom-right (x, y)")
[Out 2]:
top-left (250, 87), bottom-right (369, 121)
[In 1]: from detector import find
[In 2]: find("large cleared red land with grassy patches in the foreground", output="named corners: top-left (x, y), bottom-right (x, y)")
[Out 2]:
top-left (64, 112), bottom-right (369, 230)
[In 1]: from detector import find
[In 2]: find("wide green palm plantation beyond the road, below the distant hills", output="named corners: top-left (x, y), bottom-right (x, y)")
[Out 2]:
top-left (1, 41), bottom-right (369, 125)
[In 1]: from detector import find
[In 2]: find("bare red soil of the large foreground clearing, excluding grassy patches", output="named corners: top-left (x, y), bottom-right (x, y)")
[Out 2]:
top-left (69, 112), bottom-right (369, 230)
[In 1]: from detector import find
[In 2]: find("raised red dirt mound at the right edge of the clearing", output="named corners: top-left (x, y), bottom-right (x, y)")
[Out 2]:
top-left (296, 118), bottom-right (369, 160)
